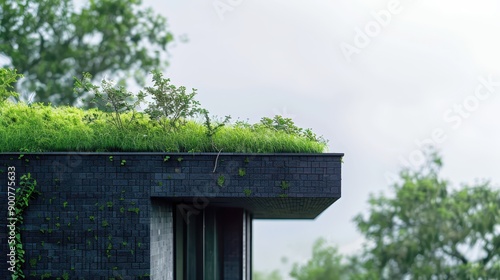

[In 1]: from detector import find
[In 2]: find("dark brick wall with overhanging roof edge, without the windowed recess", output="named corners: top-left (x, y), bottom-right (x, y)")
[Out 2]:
top-left (0, 153), bottom-right (342, 279)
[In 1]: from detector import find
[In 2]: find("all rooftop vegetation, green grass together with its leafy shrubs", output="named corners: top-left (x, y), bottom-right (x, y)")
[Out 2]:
top-left (0, 68), bottom-right (326, 153)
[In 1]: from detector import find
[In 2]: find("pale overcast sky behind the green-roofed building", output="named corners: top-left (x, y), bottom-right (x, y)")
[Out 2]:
top-left (146, 0), bottom-right (500, 272)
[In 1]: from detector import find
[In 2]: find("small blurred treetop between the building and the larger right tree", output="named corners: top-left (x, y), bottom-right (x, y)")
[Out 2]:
top-left (290, 238), bottom-right (352, 280)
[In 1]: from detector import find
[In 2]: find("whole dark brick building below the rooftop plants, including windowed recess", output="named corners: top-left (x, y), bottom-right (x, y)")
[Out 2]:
top-left (0, 153), bottom-right (343, 280)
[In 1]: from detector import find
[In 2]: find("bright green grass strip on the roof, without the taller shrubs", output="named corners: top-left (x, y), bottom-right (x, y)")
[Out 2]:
top-left (0, 101), bottom-right (326, 153)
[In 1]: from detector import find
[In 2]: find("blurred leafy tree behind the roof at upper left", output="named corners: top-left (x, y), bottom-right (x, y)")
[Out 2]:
top-left (0, 0), bottom-right (173, 105)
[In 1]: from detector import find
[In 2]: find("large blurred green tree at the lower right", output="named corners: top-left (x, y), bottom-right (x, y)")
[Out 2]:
top-left (354, 153), bottom-right (500, 279)
